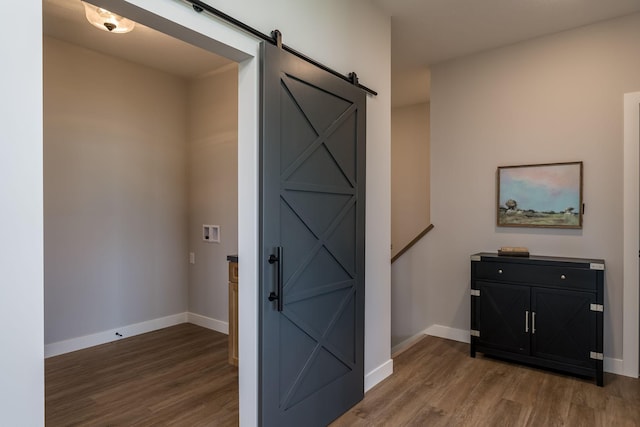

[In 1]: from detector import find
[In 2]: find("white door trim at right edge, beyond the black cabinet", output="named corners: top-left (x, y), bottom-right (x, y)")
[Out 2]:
top-left (622, 92), bottom-right (640, 378)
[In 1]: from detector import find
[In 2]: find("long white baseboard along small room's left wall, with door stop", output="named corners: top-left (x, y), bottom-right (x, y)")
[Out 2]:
top-left (44, 313), bottom-right (187, 358)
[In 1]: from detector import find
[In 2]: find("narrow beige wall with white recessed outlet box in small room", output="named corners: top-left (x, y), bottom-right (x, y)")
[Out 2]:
top-left (188, 64), bottom-right (238, 322)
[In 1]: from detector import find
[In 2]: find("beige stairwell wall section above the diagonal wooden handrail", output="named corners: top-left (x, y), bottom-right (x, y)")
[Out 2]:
top-left (391, 103), bottom-right (429, 258)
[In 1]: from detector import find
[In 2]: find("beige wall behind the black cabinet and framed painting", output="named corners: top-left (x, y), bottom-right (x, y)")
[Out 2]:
top-left (404, 14), bottom-right (640, 359)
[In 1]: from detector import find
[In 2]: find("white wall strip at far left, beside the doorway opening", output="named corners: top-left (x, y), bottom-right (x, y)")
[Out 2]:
top-left (0, 2), bottom-right (44, 426)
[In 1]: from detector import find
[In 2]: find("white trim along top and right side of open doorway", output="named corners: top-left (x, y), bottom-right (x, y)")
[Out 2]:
top-left (92, 0), bottom-right (260, 426)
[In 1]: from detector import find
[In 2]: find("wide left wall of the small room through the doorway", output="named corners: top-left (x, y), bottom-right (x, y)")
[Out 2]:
top-left (44, 37), bottom-right (188, 344)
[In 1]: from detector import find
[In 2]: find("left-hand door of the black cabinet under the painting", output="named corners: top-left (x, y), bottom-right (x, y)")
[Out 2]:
top-left (476, 282), bottom-right (531, 355)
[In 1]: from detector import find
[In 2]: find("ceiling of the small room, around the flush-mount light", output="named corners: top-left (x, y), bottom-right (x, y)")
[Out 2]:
top-left (42, 0), bottom-right (230, 79)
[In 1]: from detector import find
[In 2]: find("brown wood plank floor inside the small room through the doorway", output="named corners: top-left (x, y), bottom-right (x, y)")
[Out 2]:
top-left (45, 323), bottom-right (238, 427)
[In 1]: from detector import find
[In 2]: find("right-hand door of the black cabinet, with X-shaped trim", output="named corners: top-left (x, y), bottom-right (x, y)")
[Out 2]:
top-left (531, 288), bottom-right (597, 367)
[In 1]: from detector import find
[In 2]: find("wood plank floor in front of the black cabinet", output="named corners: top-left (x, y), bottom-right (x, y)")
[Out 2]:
top-left (332, 337), bottom-right (640, 427)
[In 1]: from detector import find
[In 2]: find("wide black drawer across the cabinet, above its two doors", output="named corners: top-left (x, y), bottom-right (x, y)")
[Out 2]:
top-left (475, 262), bottom-right (597, 290)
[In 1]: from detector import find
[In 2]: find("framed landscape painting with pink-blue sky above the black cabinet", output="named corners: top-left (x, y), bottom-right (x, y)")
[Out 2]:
top-left (497, 162), bottom-right (582, 228)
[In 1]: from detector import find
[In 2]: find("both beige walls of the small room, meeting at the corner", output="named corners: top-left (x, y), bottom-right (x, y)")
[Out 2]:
top-left (44, 37), bottom-right (238, 344)
